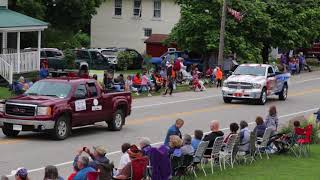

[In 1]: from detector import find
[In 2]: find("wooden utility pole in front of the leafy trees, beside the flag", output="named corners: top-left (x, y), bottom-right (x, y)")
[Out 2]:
top-left (218, 0), bottom-right (227, 65)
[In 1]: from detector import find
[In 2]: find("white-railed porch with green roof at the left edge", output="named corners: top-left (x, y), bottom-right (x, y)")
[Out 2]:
top-left (0, 8), bottom-right (48, 84)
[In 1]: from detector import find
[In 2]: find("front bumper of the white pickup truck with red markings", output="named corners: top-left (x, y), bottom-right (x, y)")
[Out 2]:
top-left (222, 87), bottom-right (262, 99)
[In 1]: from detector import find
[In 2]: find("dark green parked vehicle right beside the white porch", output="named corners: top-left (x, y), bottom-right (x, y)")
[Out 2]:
top-left (23, 48), bottom-right (67, 70)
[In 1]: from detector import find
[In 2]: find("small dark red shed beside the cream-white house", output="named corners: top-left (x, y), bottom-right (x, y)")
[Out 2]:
top-left (144, 34), bottom-right (177, 57)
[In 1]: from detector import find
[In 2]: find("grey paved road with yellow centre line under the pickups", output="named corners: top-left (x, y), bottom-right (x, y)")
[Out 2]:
top-left (0, 72), bottom-right (320, 179)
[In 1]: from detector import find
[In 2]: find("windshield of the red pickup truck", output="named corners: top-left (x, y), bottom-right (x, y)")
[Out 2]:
top-left (25, 81), bottom-right (71, 98)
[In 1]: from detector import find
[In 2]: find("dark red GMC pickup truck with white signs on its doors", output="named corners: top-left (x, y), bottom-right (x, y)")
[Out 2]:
top-left (0, 78), bottom-right (132, 140)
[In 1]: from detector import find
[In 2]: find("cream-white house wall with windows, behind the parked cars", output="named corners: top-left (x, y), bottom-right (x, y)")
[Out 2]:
top-left (91, 0), bottom-right (180, 53)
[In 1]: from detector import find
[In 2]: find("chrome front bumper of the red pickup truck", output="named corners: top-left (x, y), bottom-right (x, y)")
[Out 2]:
top-left (0, 118), bottom-right (55, 130)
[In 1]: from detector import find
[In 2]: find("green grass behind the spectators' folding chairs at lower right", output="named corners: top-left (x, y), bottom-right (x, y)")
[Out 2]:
top-left (198, 145), bottom-right (320, 180)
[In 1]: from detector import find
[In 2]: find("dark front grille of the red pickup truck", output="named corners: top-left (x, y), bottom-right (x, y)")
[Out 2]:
top-left (6, 104), bottom-right (36, 116)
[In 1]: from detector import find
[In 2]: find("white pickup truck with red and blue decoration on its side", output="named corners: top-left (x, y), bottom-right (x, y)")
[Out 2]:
top-left (222, 64), bottom-right (291, 105)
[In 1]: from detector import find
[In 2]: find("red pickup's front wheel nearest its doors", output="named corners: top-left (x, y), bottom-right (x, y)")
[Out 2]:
top-left (52, 116), bottom-right (71, 140)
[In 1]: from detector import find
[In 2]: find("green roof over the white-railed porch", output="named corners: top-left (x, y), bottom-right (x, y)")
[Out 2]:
top-left (0, 7), bottom-right (48, 31)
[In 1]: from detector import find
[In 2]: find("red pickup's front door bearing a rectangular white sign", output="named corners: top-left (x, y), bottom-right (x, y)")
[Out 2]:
top-left (71, 84), bottom-right (90, 126)
